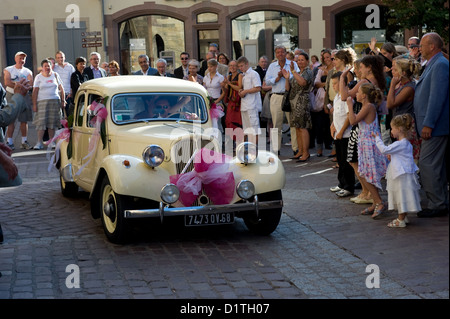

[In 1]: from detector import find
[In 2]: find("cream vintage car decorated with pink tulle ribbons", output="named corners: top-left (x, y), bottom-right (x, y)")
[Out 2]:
top-left (55, 76), bottom-right (285, 243)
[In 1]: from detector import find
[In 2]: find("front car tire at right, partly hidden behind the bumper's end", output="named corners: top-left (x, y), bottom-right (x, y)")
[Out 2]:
top-left (242, 190), bottom-right (283, 235)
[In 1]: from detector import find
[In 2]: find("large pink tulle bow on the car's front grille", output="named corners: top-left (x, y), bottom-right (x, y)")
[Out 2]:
top-left (170, 148), bottom-right (235, 206)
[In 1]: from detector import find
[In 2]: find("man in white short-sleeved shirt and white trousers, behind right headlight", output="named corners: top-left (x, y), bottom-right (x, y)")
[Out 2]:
top-left (237, 56), bottom-right (262, 144)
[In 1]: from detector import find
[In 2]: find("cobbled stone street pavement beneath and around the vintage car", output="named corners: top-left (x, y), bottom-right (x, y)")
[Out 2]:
top-left (0, 120), bottom-right (449, 300)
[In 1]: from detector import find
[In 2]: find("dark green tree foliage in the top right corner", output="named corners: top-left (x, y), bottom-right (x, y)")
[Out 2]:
top-left (382, 0), bottom-right (449, 43)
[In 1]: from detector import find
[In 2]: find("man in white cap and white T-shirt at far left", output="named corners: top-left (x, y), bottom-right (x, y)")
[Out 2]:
top-left (3, 51), bottom-right (33, 150)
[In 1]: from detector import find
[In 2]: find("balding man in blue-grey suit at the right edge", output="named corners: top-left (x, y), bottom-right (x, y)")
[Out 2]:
top-left (414, 32), bottom-right (449, 217)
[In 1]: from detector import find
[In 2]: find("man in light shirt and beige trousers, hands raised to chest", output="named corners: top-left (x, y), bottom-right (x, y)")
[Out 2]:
top-left (266, 45), bottom-right (299, 155)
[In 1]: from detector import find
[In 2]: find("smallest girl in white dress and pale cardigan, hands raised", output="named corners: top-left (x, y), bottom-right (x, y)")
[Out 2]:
top-left (375, 113), bottom-right (421, 228)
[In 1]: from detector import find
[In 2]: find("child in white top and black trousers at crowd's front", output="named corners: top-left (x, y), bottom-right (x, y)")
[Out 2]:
top-left (330, 72), bottom-right (355, 197)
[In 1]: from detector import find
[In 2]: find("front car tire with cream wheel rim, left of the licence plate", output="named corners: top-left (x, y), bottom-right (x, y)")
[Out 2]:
top-left (98, 176), bottom-right (129, 244)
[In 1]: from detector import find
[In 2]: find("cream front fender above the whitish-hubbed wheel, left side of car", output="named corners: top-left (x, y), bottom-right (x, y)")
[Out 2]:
top-left (91, 154), bottom-right (170, 201)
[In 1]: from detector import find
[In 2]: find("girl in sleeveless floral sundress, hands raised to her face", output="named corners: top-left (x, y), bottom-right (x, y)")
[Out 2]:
top-left (347, 83), bottom-right (387, 219)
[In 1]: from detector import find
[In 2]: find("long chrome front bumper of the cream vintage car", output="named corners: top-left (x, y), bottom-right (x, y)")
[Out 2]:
top-left (124, 195), bottom-right (283, 222)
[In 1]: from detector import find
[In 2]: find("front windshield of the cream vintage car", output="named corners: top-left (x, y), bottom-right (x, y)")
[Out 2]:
top-left (111, 93), bottom-right (207, 124)
